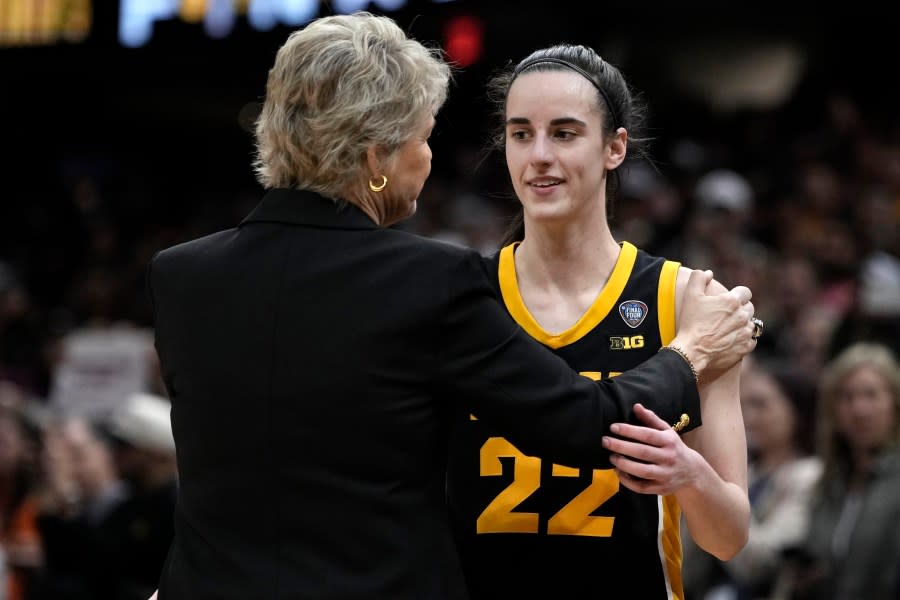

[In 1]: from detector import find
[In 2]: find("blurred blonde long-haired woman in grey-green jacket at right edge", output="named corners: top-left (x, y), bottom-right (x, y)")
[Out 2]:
top-left (782, 343), bottom-right (900, 600)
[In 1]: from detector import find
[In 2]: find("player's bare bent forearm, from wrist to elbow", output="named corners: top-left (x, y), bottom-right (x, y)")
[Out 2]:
top-left (675, 462), bottom-right (750, 560)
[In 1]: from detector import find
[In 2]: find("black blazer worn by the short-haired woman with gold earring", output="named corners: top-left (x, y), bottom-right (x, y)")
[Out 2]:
top-left (148, 190), bottom-right (699, 600)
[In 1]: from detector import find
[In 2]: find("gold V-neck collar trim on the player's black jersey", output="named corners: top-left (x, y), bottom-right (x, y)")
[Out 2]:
top-left (498, 242), bottom-right (640, 350)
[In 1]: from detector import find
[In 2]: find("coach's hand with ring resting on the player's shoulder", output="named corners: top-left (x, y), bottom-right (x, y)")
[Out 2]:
top-left (669, 270), bottom-right (756, 379)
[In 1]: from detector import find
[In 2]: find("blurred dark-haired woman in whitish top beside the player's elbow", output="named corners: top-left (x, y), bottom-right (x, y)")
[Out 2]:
top-left (684, 357), bottom-right (822, 600)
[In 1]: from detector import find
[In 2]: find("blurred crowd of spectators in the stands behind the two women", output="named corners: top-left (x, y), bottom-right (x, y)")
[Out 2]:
top-left (0, 68), bottom-right (900, 600)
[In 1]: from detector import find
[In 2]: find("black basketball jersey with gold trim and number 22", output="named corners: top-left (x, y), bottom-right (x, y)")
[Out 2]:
top-left (447, 242), bottom-right (683, 600)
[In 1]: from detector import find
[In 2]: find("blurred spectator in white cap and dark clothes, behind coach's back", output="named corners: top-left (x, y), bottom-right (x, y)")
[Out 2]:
top-left (29, 394), bottom-right (177, 600)
